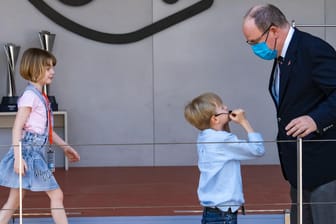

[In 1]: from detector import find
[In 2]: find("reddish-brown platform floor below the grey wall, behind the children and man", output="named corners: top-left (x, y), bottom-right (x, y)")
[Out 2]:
top-left (0, 165), bottom-right (290, 216)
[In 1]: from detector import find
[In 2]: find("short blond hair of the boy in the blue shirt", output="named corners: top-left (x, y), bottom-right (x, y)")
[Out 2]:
top-left (184, 93), bottom-right (223, 130)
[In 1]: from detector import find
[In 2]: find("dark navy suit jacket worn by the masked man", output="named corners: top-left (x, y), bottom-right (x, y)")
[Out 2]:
top-left (269, 29), bottom-right (336, 190)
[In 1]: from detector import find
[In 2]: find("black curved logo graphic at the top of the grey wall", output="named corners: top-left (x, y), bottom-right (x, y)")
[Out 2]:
top-left (29, 0), bottom-right (214, 44)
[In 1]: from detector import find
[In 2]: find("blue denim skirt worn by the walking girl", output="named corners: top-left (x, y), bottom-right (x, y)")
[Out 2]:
top-left (0, 132), bottom-right (59, 191)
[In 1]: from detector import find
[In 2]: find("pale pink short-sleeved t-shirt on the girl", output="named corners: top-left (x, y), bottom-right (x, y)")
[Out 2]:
top-left (18, 90), bottom-right (47, 134)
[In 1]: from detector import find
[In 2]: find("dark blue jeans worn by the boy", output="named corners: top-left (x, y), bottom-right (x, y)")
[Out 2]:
top-left (202, 207), bottom-right (238, 224)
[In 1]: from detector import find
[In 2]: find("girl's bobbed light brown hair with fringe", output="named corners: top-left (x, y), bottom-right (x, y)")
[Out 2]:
top-left (20, 48), bottom-right (56, 82)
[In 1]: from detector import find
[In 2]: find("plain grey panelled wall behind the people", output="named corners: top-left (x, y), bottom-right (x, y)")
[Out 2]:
top-left (0, 0), bottom-right (336, 166)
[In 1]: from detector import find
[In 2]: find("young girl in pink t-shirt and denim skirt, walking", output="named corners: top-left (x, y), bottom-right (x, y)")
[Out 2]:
top-left (0, 48), bottom-right (80, 224)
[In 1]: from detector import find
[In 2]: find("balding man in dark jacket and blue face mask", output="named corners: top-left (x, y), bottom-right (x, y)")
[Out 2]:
top-left (243, 4), bottom-right (336, 224)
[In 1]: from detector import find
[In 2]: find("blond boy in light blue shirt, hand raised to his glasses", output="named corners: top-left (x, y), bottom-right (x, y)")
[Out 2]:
top-left (184, 93), bottom-right (265, 224)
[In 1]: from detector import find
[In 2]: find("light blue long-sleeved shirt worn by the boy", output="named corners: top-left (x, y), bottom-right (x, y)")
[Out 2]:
top-left (197, 129), bottom-right (265, 212)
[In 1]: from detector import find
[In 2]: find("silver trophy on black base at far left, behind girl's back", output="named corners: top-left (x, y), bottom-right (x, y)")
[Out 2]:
top-left (1, 43), bottom-right (20, 111)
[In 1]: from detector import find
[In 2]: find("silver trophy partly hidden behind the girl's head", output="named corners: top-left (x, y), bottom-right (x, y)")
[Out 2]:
top-left (39, 30), bottom-right (58, 111)
